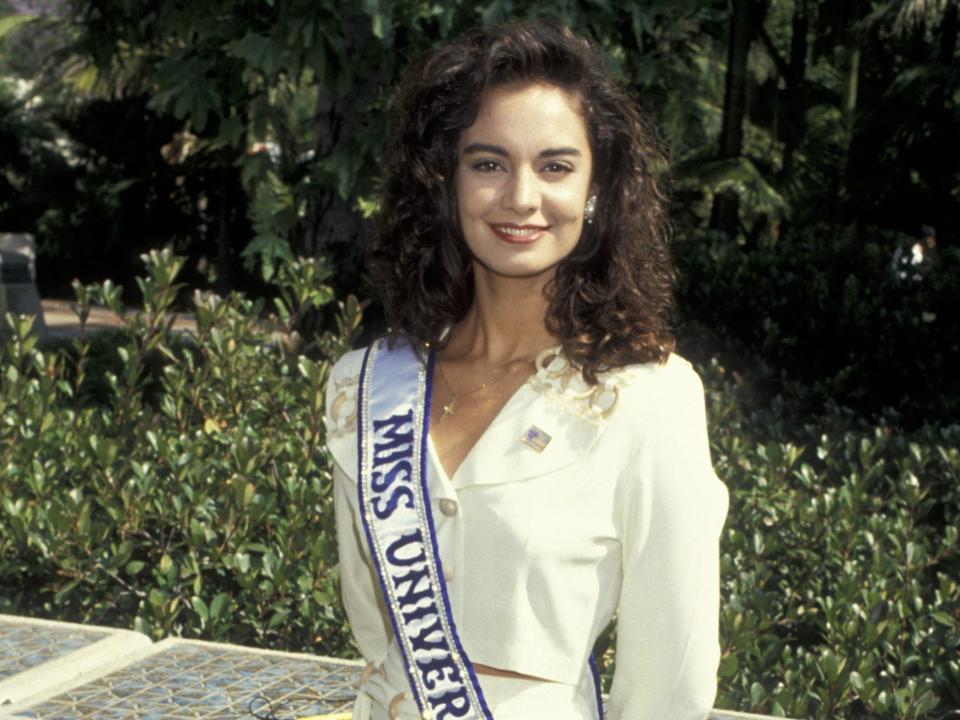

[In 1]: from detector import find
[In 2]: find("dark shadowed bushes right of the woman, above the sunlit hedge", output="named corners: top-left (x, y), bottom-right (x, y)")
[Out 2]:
top-left (678, 226), bottom-right (960, 424)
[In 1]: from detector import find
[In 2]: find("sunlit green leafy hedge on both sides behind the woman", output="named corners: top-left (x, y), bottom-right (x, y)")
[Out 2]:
top-left (0, 253), bottom-right (960, 720)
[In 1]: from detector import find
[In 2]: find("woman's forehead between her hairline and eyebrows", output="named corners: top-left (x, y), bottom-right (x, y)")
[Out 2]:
top-left (459, 83), bottom-right (589, 151)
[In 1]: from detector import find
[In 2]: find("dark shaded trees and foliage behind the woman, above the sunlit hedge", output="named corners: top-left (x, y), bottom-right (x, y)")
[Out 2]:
top-left (0, 0), bottom-right (960, 422)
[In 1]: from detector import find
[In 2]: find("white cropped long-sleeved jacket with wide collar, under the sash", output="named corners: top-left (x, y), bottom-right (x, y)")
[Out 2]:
top-left (327, 349), bottom-right (727, 720)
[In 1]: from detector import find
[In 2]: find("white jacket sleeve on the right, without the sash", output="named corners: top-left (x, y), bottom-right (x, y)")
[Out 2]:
top-left (609, 365), bottom-right (727, 720)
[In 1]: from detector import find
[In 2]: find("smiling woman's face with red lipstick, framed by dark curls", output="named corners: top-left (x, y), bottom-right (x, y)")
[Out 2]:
top-left (456, 84), bottom-right (593, 278)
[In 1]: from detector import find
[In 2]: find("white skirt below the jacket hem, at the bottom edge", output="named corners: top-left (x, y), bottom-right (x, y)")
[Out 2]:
top-left (353, 643), bottom-right (597, 720)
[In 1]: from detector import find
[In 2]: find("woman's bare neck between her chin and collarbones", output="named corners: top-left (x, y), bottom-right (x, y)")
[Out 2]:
top-left (446, 265), bottom-right (557, 365)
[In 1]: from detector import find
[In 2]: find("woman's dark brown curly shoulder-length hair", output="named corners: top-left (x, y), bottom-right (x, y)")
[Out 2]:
top-left (368, 20), bottom-right (674, 383)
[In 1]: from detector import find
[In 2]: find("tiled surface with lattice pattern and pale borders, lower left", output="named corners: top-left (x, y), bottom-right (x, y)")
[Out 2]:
top-left (0, 615), bottom-right (363, 720)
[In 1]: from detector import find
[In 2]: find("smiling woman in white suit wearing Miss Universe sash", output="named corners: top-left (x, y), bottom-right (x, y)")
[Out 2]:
top-left (327, 22), bottom-right (727, 720)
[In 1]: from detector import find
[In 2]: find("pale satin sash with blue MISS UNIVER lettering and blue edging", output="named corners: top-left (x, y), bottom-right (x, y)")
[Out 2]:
top-left (357, 340), bottom-right (602, 720)
